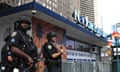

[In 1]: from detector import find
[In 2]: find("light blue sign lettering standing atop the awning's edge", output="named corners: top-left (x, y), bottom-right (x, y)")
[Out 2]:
top-left (72, 9), bottom-right (105, 36)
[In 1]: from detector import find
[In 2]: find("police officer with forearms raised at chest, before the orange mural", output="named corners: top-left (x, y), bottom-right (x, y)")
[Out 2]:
top-left (43, 32), bottom-right (63, 72)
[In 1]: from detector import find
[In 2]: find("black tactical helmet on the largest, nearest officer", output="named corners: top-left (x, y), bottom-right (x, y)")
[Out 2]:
top-left (15, 16), bottom-right (32, 29)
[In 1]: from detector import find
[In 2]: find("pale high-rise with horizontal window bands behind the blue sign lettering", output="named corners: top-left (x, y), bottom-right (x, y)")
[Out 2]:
top-left (80, 0), bottom-right (102, 28)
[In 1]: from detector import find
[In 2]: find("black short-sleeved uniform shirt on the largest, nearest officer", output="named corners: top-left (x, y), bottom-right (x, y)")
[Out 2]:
top-left (10, 31), bottom-right (37, 60)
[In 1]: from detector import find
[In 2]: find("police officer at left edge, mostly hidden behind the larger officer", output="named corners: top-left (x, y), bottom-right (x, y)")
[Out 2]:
top-left (1, 35), bottom-right (13, 72)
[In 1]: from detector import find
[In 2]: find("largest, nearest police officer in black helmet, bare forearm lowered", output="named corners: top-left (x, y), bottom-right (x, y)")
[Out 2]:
top-left (6, 16), bottom-right (37, 72)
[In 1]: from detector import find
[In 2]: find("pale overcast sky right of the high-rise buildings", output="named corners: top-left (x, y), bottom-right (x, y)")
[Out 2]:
top-left (101, 0), bottom-right (120, 33)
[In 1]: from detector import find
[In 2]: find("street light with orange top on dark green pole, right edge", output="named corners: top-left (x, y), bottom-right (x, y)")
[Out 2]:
top-left (112, 32), bottom-right (120, 72)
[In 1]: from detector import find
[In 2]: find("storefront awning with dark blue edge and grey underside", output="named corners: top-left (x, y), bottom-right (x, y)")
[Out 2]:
top-left (0, 3), bottom-right (107, 47)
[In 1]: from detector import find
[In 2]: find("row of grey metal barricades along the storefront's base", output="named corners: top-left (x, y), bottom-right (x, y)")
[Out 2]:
top-left (62, 62), bottom-right (111, 72)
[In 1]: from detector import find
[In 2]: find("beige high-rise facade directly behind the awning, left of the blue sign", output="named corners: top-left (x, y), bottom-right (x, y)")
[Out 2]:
top-left (36, 0), bottom-right (73, 20)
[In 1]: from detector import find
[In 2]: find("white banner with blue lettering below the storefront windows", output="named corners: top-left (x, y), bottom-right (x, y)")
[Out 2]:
top-left (67, 50), bottom-right (96, 62)
